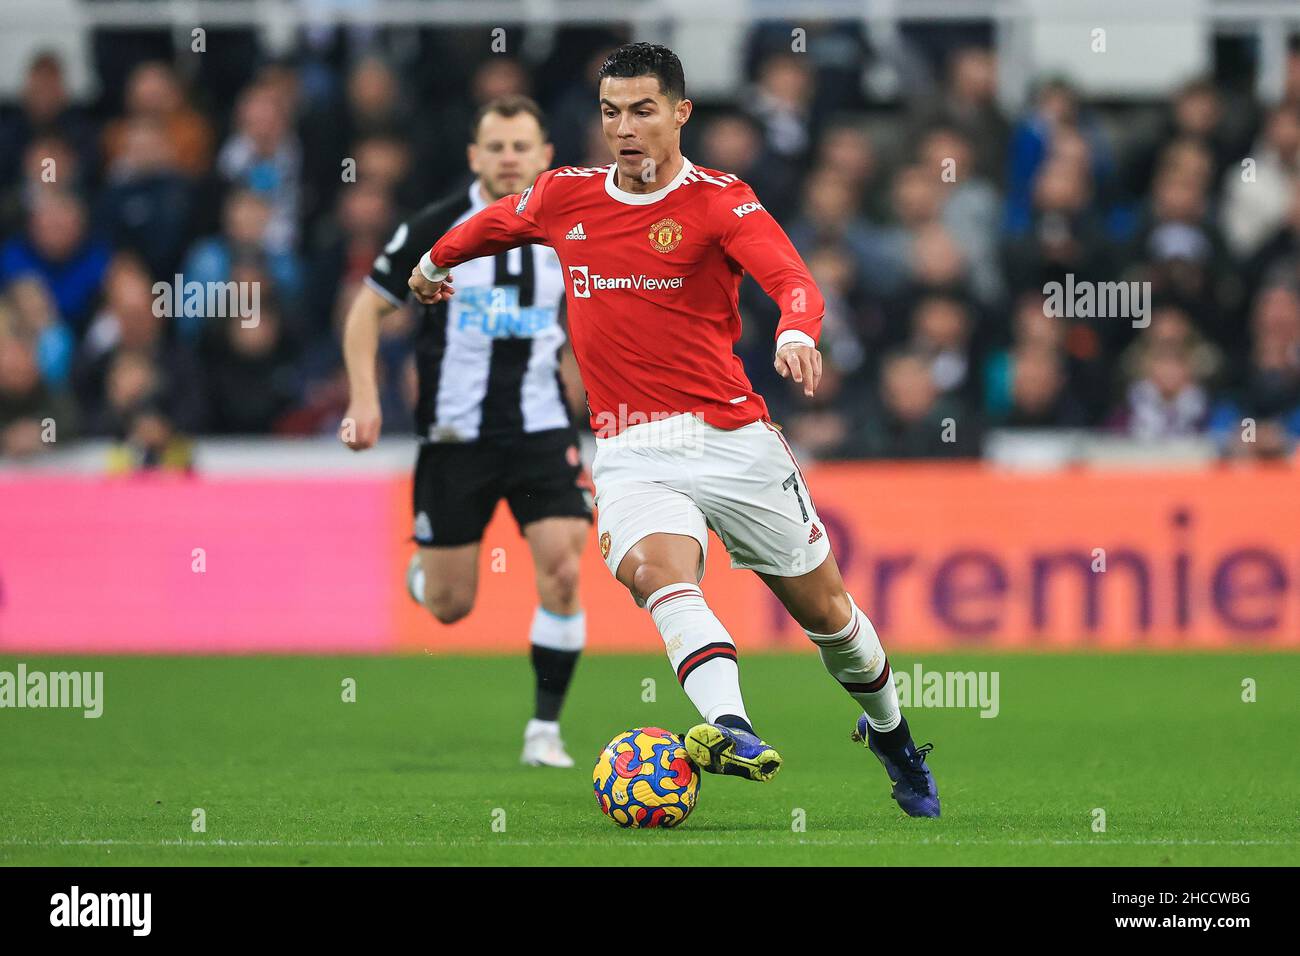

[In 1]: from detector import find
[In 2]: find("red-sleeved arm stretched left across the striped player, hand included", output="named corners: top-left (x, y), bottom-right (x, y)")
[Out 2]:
top-left (408, 173), bottom-right (550, 306)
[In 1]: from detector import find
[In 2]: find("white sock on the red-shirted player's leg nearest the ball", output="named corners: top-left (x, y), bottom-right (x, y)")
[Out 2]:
top-left (646, 583), bottom-right (749, 723)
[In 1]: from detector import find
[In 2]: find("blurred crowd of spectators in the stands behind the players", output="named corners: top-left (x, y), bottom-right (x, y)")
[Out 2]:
top-left (0, 23), bottom-right (1300, 462)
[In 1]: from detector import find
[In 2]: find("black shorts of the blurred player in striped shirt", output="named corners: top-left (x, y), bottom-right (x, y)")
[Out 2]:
top-left (413, 428), bottom-right (592, 548)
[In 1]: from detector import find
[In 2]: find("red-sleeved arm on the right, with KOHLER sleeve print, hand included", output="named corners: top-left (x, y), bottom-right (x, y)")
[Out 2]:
top-left (712, 182), bottom-right (826, 397)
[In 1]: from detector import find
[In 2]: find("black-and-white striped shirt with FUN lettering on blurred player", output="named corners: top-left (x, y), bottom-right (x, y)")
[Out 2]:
top-left (367, 179), bottom-right (572, 441)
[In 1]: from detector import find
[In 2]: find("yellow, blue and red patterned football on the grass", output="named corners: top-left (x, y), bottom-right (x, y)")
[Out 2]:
top-left (592, 727), bottom-right (699, 829)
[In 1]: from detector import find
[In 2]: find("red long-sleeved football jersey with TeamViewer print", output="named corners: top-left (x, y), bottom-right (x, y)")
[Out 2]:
top-left (429, 157), bottom-right (824, 436)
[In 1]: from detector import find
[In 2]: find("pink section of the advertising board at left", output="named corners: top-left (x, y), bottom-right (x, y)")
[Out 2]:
top-left (0, 476), bottom-right (398, 653)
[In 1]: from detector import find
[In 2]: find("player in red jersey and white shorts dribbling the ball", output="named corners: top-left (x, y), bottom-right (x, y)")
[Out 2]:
top-left (408, 43), bottom-right (940, 817)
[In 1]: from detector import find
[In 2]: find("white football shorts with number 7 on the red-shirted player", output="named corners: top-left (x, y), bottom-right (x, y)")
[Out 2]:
top-left (592, 415), bottom-right (831, 606)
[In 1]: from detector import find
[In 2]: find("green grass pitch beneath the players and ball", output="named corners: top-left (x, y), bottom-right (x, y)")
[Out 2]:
top-left (0, 652), bottom-right (1300, 866)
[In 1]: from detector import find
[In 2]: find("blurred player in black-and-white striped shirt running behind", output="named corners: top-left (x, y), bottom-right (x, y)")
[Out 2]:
top-left (341, 96), bottom-right (592, 767)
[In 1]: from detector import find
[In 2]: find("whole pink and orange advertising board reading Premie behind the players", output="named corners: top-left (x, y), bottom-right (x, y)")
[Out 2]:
top-left (0, 464), bottom-right (1300, 653)
